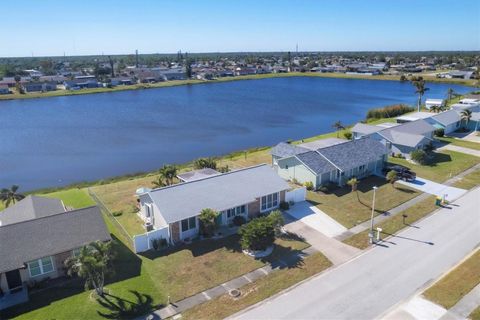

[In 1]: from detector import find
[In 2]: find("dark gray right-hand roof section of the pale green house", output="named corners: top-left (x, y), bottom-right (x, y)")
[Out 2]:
top-left (318, 138), bottom-right (388, 171)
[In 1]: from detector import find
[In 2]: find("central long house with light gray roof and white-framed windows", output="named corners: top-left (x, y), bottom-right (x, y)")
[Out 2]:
top-left (139, 164), bottom-right (291, 244)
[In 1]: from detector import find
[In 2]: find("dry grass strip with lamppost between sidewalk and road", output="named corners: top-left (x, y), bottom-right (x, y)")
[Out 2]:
top-left (343, 196), bottom-right (438, 249)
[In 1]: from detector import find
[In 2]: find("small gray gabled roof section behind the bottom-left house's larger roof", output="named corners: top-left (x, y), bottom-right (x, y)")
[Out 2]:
top-left (0, 195), bottom-right (65, 226)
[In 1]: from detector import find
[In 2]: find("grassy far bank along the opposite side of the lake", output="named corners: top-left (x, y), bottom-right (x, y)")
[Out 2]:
top-left (0, 72), bottom-right (480, 101)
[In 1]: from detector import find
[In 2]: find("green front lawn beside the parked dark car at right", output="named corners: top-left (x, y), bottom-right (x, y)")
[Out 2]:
top-left (389, 151), bottom-right (480, 182)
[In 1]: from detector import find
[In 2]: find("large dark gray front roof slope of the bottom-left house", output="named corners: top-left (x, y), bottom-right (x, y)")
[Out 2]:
top-left (0, 207), bottom-right (111, 272)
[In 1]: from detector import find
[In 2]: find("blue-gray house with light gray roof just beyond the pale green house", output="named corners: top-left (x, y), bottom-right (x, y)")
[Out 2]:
top-left (352, 115), bottom-right (437, 158)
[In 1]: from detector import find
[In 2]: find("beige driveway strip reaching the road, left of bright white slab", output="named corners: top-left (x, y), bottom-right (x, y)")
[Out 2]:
top-left (284, 215), bottom-right (361, 265)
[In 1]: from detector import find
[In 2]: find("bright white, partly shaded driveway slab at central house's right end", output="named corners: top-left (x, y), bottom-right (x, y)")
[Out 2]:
top-left (287, 201), bottom-right (347, 237)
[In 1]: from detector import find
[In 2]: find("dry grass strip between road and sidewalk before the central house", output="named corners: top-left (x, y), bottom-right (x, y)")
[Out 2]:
top-left (182, 253), bottom-right (332, 319)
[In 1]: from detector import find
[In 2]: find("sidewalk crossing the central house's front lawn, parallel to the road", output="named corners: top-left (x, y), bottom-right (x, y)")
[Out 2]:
top-left (136, 247), bottom-right (317, 320)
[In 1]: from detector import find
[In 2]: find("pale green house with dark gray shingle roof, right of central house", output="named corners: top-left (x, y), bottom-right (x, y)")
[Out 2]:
top-left (271, 138), bottom-right (388, 189)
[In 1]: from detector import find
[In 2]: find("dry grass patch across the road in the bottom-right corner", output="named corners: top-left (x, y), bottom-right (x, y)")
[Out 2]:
top-left (423, 250), bottom-right (480, 309)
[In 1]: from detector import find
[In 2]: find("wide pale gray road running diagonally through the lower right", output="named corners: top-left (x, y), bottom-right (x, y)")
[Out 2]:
top-left (233, 188), bottom-right (480, 319)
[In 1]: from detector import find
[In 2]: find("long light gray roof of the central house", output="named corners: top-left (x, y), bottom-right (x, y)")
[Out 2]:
top-left (148, 164), bottom-right (290, 223)
